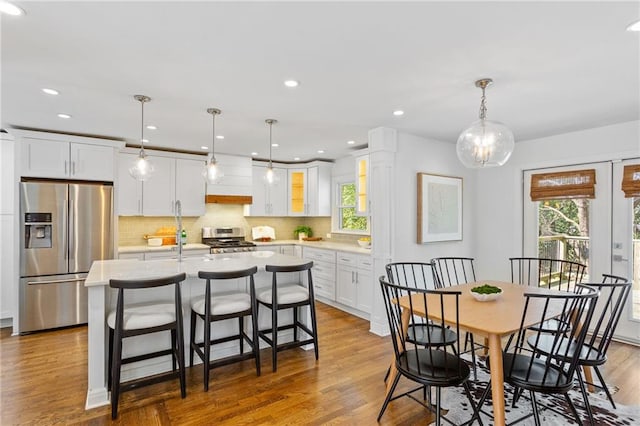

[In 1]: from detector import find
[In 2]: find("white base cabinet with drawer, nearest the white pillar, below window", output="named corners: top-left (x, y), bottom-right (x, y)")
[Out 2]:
top-left (336, 252), bottom-right (372, 313)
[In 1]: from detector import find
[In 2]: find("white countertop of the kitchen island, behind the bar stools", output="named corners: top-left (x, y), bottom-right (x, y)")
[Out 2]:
top-left (85, 251), bottom-right (306, 287)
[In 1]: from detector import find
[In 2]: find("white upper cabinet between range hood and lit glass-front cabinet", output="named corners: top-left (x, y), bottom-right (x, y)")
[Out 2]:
top-left (249, 166), bottom-right (287, 216)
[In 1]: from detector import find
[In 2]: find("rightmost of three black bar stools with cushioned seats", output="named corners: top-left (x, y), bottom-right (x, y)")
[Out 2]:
top-left (257, 262), bottom-right (318, 372)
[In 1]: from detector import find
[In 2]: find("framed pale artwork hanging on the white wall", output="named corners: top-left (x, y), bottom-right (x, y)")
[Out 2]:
top-left (418, 173), bottom-right (462, 244)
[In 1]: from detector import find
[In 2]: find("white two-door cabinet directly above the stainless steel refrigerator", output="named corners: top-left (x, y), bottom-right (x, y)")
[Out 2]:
top-left (21, 137), bottom-right (115, 182)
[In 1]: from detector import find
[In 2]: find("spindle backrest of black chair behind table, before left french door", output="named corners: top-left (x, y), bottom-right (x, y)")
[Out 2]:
top-left (509, 257), bottom-right (587, 291)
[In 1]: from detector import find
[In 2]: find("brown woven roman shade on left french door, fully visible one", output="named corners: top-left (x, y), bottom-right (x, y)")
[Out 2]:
top-left (531, 169), bottom-right (596, 201)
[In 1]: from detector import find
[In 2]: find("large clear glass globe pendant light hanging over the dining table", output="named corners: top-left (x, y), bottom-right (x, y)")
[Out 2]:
top-left (456, 78), bottom-right (514, 168)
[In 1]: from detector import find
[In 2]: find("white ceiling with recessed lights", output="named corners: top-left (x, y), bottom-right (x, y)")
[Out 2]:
top-left (1, 1), bottom-right (640, 161)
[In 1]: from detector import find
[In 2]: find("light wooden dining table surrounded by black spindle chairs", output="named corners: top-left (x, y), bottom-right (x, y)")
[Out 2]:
top-left (386, 280), bottom-right (563, 426)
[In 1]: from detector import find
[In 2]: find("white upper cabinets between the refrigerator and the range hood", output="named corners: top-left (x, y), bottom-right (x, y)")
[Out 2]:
top-left (116, 150), bottom-right (205, 216)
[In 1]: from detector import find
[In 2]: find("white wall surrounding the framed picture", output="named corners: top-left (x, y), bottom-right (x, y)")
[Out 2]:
top-left (392, 132), bottom-right (476, 262)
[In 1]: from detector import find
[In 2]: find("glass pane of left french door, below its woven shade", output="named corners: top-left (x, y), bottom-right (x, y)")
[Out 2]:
top-left (538, 198), bottom-right (589, 282)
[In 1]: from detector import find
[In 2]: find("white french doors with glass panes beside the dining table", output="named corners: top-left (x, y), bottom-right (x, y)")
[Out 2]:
top-left (523, 159), bottom-right (640, 343)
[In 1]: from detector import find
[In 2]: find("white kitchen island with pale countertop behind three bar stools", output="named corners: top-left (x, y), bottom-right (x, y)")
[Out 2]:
top-left (85, 251), bottom-right (309, 409)
